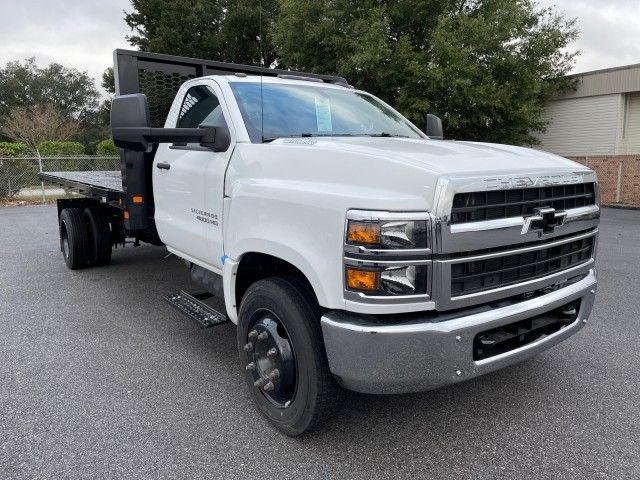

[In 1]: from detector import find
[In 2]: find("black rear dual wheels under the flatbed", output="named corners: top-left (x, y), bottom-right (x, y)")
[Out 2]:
top-left (60, 207), bottom-right (111, 270)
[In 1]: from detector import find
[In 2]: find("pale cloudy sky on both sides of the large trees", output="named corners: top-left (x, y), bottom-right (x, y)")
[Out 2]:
top-left (0, 0), bottom-right (640, 96)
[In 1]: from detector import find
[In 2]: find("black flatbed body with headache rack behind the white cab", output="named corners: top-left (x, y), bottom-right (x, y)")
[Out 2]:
top-left (40, 49), bottom-right (348, 239)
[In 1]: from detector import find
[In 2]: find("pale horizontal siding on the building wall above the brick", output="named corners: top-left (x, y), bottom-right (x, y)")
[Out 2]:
top-left (538, 94), bottom-right (622, 156)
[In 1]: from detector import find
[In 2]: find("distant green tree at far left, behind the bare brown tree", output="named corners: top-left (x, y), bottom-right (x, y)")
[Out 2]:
top-left (0, 58), bottom-right (99, 119)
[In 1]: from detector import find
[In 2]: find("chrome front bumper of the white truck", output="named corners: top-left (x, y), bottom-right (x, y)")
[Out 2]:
top-left (321, 269), bottom-right (597, 393)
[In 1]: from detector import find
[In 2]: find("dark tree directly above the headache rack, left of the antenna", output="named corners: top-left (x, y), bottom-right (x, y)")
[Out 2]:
top-left (124, 0), bottom-right (278, 65)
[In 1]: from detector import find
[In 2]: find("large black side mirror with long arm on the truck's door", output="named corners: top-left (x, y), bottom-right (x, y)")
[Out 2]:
top-left (111, 93), bottom-right (231, 152)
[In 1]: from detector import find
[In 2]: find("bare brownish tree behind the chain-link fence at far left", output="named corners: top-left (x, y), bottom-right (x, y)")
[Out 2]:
top-left (0, 103), bottom-right (80, 150)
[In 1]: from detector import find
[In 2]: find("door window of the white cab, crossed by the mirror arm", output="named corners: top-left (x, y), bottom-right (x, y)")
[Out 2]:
top-left (174, 85), bottom-right (227, 147)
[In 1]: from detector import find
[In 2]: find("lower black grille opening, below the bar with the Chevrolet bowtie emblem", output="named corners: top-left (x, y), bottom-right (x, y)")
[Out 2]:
top-left (451, 236), bottom-right (594, 298)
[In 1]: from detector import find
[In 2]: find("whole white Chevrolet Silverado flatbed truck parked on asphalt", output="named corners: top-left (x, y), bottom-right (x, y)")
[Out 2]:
top-left (42, 50), bottom-right (600, 435)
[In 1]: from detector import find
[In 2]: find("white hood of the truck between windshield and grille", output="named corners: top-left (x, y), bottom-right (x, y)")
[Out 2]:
top-left (225, 137), bottom-right (589, 211)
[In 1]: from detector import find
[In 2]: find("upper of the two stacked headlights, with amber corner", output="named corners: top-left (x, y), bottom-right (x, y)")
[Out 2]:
top-left (347, 220), bottom-right (427, 249)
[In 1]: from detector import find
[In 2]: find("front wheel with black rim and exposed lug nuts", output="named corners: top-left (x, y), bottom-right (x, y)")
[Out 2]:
top-left (238, 277), bottom-right (341, 436)
